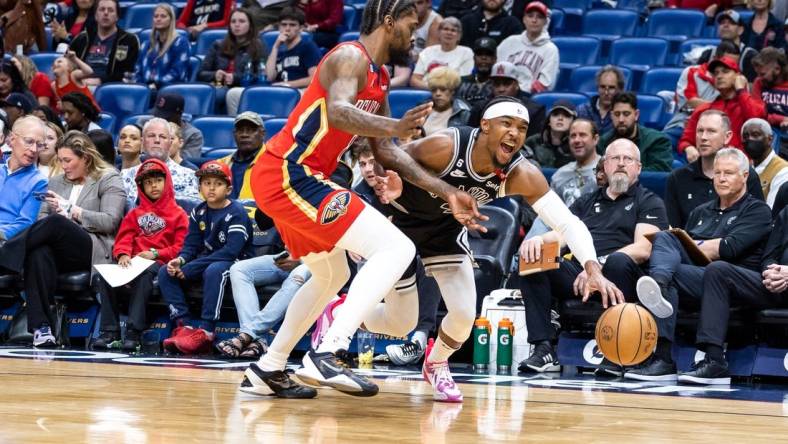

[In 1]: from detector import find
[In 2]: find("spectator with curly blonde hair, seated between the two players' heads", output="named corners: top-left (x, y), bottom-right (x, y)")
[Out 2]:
top-left (424, 66), bottom-right (471, 136)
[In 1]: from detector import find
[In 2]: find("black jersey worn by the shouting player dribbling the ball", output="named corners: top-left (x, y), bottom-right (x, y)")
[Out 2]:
top-left (390, 126), bottom-right (525, 221)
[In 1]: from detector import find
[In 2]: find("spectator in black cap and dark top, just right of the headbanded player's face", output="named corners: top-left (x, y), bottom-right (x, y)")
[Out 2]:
top-left (525, 100), bottom-right (577, 168)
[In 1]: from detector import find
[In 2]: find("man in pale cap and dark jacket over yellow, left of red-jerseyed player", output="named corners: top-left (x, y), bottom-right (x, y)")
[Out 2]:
top-left (219, 111), bottom-right (265, 200)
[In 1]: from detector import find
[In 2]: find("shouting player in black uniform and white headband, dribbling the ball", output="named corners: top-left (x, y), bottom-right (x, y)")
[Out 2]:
top-left (364, 97), bottom-right (624, 402)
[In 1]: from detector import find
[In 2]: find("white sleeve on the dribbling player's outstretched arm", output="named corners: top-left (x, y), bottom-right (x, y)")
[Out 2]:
top-left (532, 190), bottom-right (598, 265)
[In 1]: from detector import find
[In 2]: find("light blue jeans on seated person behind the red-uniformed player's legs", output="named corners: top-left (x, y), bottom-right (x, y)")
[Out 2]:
top-left (230, 255), bottom-right (311, 339)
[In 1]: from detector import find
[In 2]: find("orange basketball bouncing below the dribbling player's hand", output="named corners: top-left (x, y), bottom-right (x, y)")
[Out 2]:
top-left (594, 304), bottom-right (657, 366)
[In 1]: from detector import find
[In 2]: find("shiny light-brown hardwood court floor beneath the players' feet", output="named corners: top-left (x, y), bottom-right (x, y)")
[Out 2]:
top-left (0, 358), bottom-right (788, 444)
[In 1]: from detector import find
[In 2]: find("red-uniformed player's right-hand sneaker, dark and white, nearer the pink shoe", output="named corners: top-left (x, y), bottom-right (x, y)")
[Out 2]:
top-left (296, 350), bottom-right (378, 396)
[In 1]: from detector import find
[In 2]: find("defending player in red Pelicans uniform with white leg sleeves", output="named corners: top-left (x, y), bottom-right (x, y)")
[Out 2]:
top-left (241, 0), bottom-right (484, 398)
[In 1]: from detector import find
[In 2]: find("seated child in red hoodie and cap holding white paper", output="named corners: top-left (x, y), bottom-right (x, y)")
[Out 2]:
top-left (93, 159), bottom-right (189, 350)
